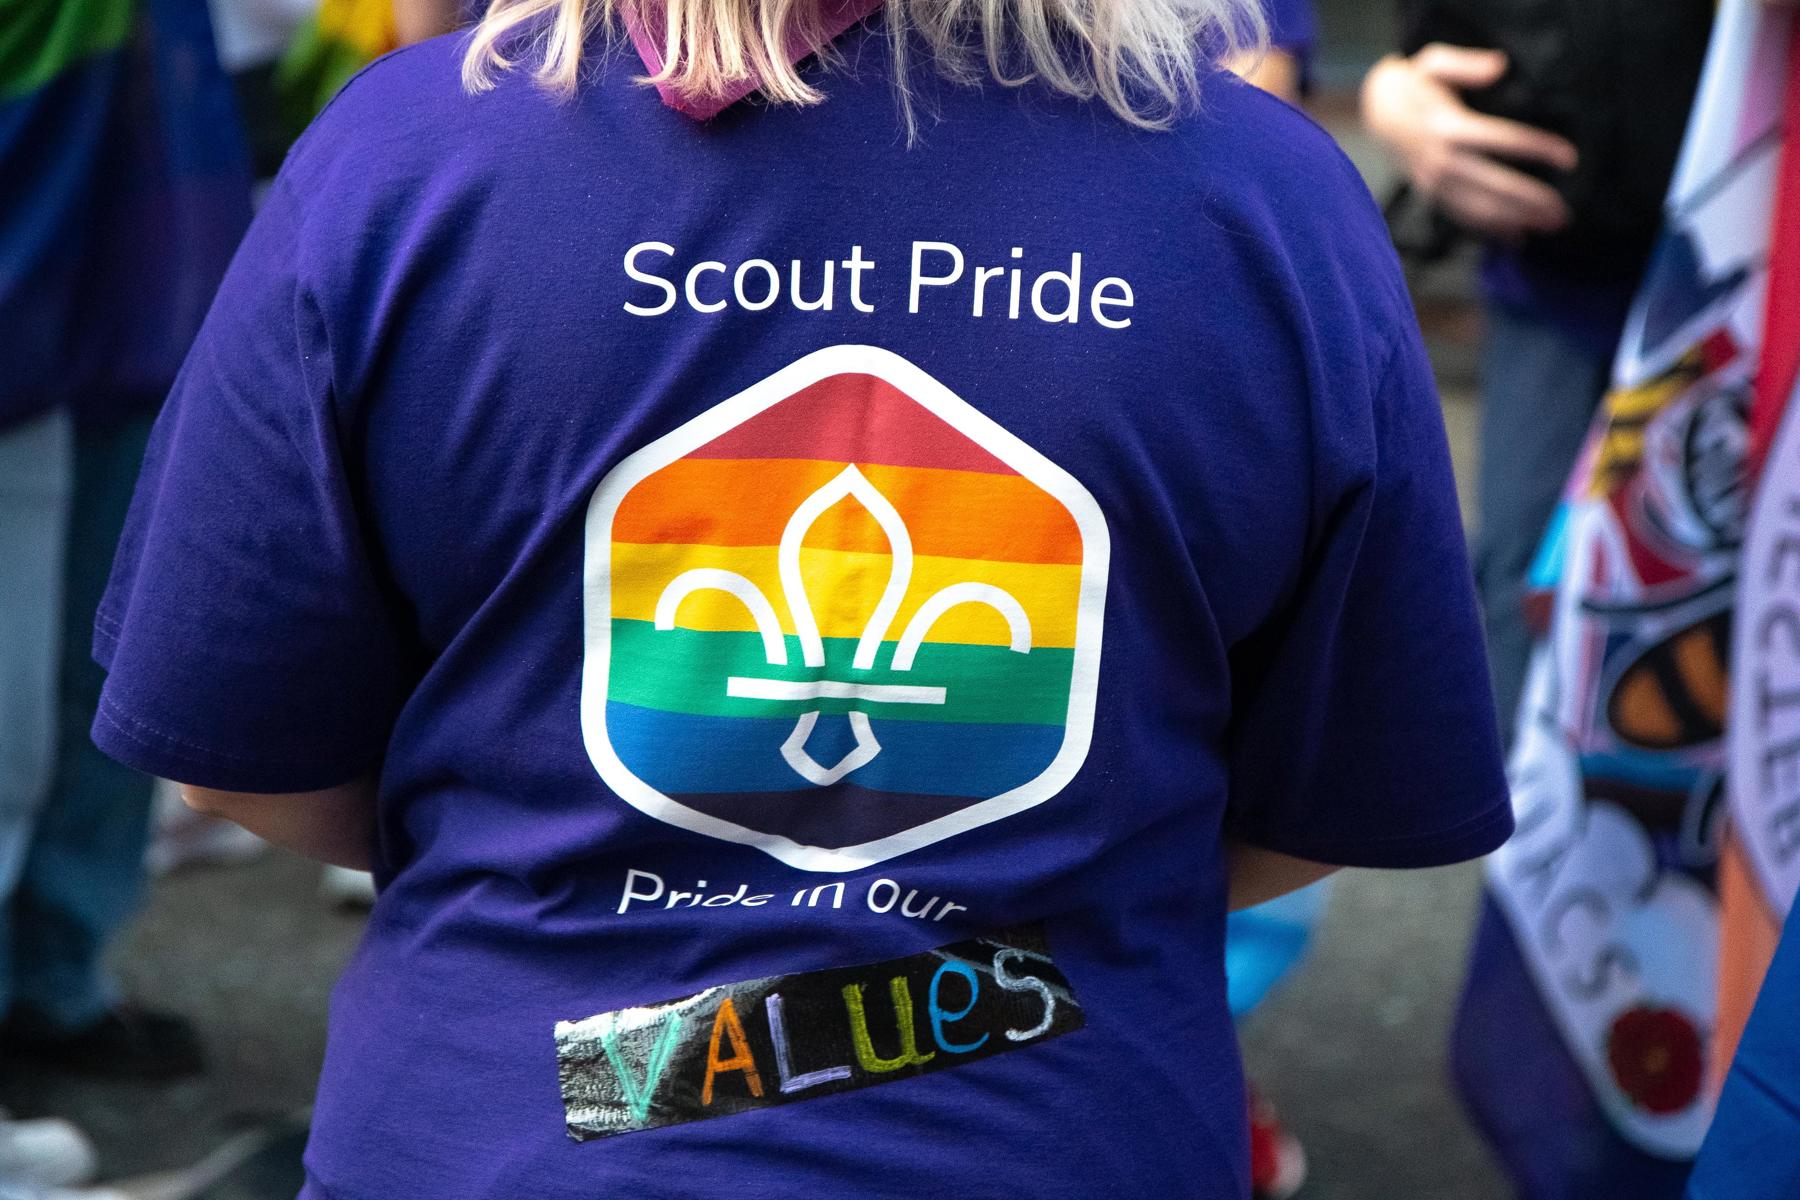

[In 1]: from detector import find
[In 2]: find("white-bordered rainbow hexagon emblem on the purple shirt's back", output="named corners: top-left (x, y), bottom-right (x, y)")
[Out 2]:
top-left (583, 347), bottom-right (1107, 869)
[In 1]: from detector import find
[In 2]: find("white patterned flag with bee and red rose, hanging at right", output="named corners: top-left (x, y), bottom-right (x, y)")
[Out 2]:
top-left (1453, 0), bottom-right (1789, 1200)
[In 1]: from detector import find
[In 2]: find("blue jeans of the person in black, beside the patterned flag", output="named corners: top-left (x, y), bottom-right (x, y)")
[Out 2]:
top-left (1474, 304), bottom-right (1613, 743)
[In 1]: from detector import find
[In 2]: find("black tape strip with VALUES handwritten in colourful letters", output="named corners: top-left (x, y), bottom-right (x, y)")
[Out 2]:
top-left (556, 927), bottom-right (1084, 1141)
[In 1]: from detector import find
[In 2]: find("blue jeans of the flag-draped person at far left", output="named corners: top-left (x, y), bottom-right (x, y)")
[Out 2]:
top-left (0, 414), bottom-right (153, 1027)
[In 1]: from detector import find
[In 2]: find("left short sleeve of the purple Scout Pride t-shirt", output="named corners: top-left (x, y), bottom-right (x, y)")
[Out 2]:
top-left (94, 180), bottom-right (405, 792)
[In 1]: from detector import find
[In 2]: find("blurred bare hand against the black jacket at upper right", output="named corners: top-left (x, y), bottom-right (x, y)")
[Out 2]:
top-left (1363, 43), bottom-right (1577, 241)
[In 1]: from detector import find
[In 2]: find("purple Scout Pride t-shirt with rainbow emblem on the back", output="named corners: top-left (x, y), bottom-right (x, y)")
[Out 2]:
top-left (95, 29), bottom-right (1510, 1200)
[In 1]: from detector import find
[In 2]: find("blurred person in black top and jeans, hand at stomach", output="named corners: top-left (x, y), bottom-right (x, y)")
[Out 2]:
top-left (1363, 0), bottom-right (1714, 752)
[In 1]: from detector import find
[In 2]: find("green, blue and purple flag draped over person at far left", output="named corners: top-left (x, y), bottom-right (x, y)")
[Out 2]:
top-left (0, 0), bottom-right (250, 426)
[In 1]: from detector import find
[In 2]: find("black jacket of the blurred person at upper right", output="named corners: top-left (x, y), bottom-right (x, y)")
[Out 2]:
top-left (1400, 0), bottom-right (1714, 282)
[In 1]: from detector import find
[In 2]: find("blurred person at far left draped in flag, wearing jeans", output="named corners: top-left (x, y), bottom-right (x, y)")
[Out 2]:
top-left (0, 0), bottom-right (248, 1101)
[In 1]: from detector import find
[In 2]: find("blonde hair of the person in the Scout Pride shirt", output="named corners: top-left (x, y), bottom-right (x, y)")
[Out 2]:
top-left (463, 0), bottom-right (1267, 137)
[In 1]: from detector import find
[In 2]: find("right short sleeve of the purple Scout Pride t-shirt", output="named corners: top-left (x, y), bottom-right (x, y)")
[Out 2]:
top-left (1228, 322), bottom-right (1512, 867)
